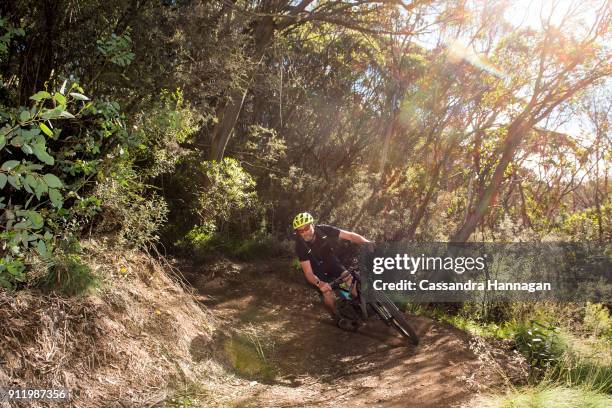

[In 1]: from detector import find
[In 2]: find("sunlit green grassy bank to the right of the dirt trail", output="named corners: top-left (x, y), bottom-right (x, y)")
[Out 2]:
top-left (408, 303), bottom-right (612, 407)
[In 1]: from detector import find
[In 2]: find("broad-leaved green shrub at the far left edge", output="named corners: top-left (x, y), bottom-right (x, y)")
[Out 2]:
top-left (0, 85), bottom-right (94, 287)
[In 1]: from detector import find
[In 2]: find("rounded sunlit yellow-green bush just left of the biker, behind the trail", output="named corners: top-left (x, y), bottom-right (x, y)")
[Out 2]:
top-left (163, 154), bottom-right (265, 256)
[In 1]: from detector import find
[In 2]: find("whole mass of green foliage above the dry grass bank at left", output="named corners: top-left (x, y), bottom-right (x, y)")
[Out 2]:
top-left (0, 84), bottom-right (172, 288)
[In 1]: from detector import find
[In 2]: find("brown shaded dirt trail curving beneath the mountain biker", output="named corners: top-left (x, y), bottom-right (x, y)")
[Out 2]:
top-left (189, 261), bottom-right (512, 407)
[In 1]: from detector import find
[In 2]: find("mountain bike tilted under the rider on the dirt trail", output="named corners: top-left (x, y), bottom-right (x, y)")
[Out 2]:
top-left (329, 271), bottom-right (419, 346)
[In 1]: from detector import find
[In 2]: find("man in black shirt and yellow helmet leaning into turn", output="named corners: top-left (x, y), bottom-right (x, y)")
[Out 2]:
top-left (293, 212), bottom-right (372, 330)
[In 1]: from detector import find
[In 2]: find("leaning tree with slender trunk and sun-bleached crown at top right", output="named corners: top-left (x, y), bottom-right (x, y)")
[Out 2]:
top-left (452, 1), bottom-right (612, 241)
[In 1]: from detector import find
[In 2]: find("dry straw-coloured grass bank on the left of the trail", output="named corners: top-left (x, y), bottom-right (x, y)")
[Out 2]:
top-left (0, 242), bottom-right (232, 407)
